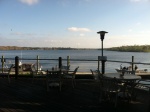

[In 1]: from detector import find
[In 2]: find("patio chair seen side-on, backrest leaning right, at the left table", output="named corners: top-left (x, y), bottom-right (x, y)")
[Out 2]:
top-left (63, 66), bottom-right (79, 88)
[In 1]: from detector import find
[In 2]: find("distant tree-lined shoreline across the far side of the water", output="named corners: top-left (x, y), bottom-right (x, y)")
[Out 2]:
top-left (0, 45), bottom-right (150, 52)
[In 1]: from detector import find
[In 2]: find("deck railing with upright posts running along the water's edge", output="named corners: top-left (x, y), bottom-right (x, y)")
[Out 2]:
top-left (0, 56), bottom-right (150, 78)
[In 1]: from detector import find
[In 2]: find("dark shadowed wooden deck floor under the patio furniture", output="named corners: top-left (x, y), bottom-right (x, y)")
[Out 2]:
top-left (0, 78), bottom-right (149, 112)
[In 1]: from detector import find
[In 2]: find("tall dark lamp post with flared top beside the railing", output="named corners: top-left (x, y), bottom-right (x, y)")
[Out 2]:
top-left (97, 31), bottom-right (108, 74)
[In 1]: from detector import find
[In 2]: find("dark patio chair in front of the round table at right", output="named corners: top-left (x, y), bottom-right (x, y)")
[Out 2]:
top-left (100, 77), bottom-right (120, 108)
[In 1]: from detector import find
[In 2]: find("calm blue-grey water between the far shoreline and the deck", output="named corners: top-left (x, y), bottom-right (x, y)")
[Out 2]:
top-left (0, 50), bottom-right (150, 72)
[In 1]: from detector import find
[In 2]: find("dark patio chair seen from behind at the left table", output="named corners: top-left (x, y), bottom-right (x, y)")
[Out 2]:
top-left (46, 70), bottom-right (63, 91)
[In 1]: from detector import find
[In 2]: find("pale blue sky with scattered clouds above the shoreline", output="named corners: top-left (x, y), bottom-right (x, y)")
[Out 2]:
top-left (0, 0), bottom-right (150, 48)
